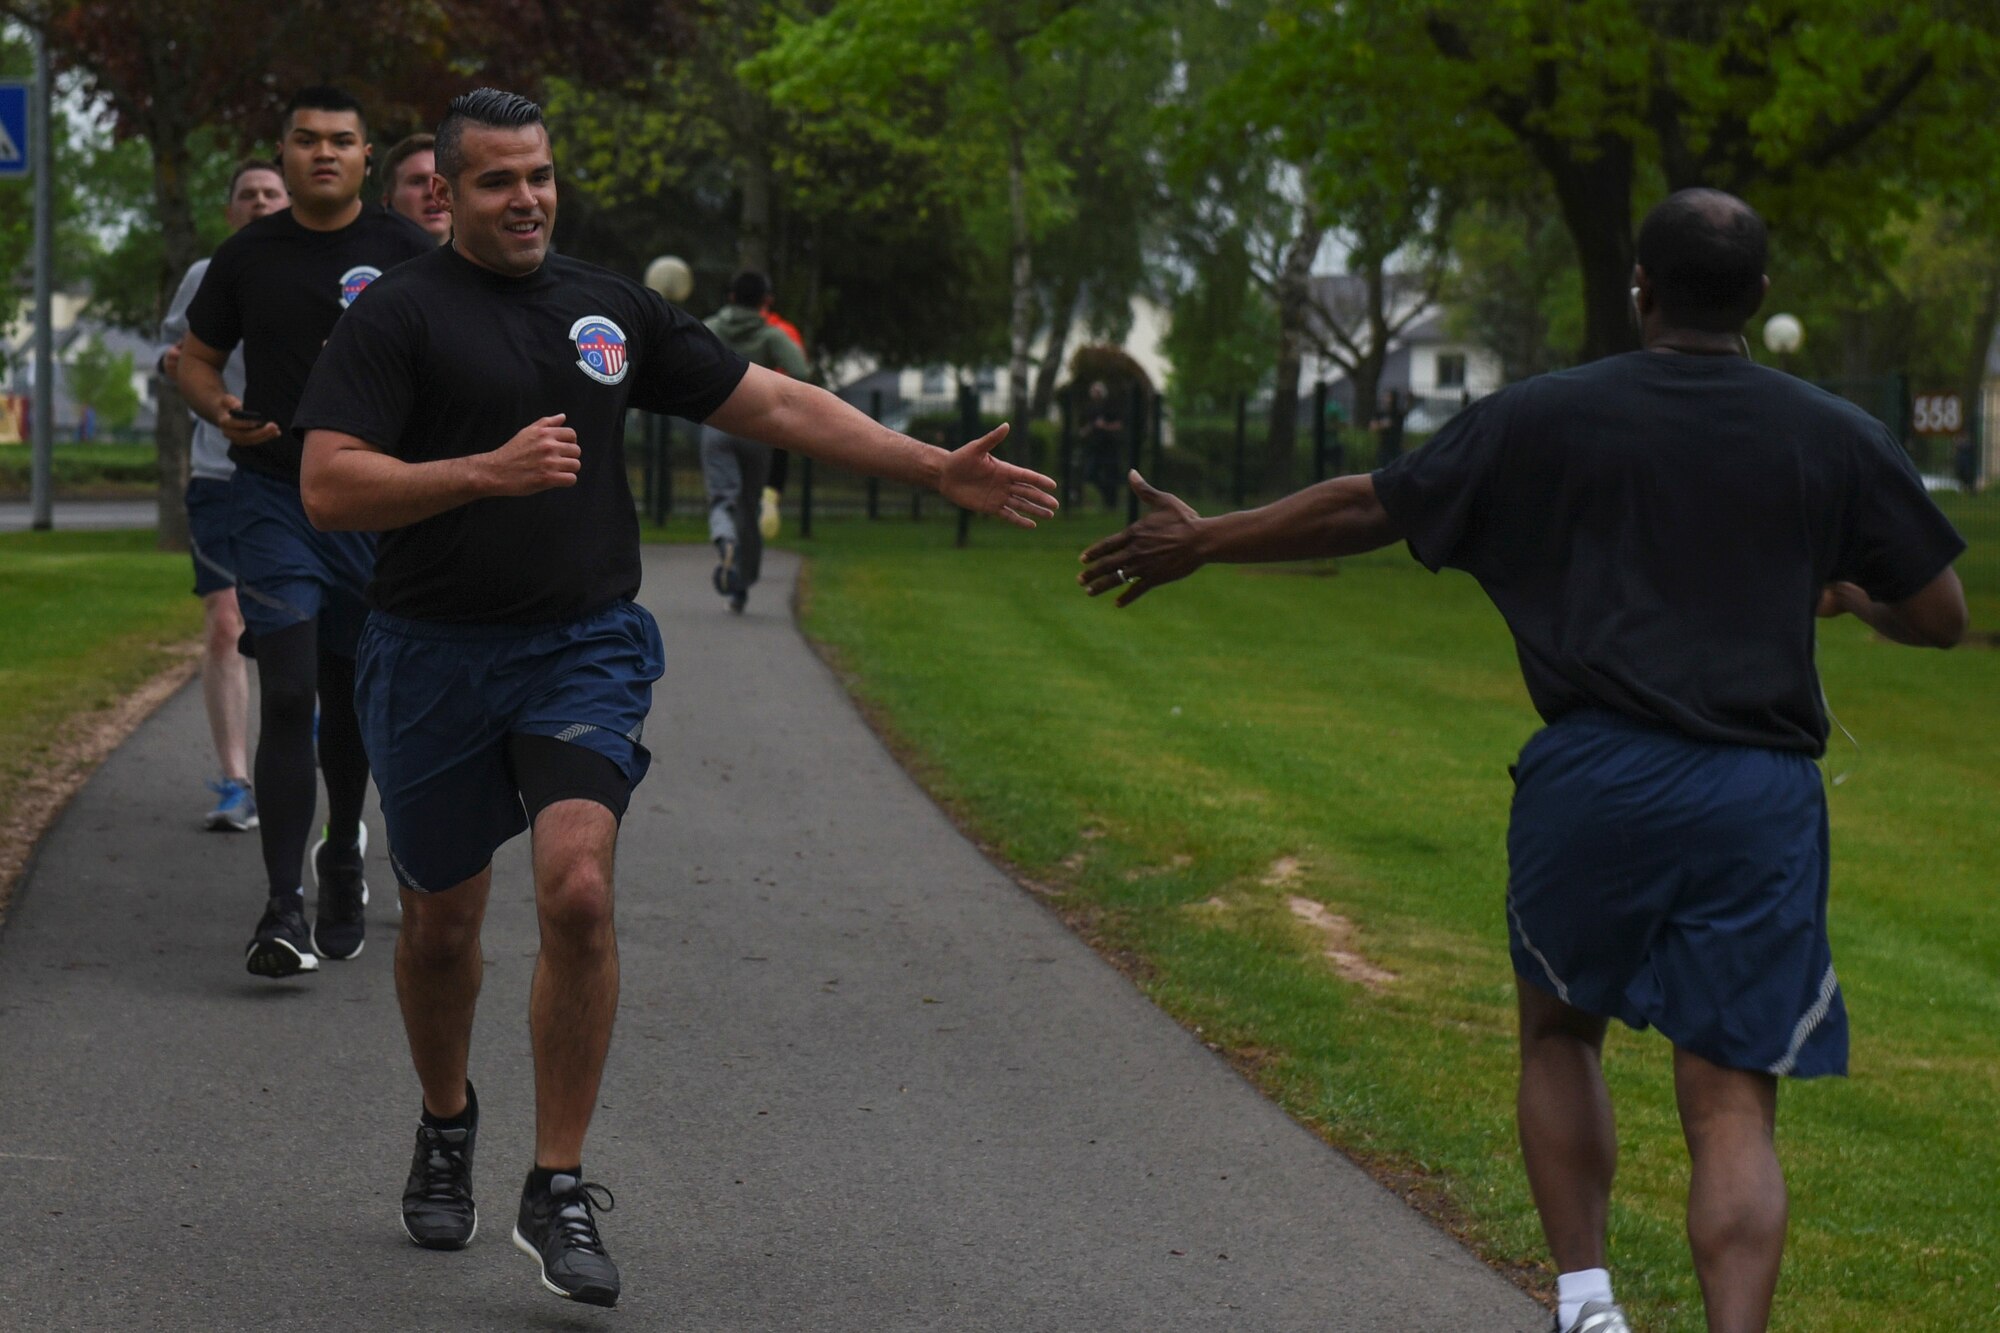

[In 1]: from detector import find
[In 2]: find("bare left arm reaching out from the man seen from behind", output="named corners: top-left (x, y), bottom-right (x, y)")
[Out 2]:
top-left (1076, 472), bottom-right (1402, 606)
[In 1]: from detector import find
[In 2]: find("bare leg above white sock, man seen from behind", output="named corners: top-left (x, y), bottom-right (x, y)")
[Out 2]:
top-left (1514, 977), bottom-right (1618, 1273)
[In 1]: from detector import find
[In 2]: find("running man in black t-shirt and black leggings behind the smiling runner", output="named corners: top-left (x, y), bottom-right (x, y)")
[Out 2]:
top-left (180, 88), bottom-right (434, 977)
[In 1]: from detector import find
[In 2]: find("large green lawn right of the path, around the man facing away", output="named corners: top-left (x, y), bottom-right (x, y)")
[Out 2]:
top-left (784, 518), bottom-right (2000, 1333)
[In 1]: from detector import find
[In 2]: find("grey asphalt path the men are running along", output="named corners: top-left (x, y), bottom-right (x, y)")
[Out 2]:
top-left (0, 548), bottom-right (1548, 1333)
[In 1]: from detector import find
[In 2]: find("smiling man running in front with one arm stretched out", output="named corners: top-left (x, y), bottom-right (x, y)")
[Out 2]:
top-left (294, 88), bottom-right (1054, 1305)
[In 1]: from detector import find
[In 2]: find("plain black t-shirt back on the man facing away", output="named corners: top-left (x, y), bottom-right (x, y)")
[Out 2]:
top-left (1374, 352), bottom-right (1966, 755)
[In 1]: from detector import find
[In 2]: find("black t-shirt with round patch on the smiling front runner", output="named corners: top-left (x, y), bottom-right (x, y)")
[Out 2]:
top-left (292, 246), bottom-right (748, 624)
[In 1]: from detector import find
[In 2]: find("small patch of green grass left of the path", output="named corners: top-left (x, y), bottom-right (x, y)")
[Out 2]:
top-left (0, 532), bottom-right (202, 809)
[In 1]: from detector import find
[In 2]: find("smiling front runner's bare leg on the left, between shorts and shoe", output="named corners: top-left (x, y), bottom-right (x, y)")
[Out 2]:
top-left (396, 865), bottom-right (494, 1119)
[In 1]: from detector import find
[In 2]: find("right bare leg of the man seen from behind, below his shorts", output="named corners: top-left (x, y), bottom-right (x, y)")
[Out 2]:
top-left (1674, 1049), bottom-right (1786, 1333)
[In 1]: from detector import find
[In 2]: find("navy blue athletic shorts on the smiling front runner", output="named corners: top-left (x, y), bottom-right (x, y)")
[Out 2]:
top-left (354, 602), bottom-right (666, 893)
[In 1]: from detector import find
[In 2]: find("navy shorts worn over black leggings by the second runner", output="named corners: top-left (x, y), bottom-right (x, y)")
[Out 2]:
top-left (230, 468), bottom-right (374, 656)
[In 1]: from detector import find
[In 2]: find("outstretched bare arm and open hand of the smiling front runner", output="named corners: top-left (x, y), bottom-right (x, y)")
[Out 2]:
top-left (706, 366), bottom-right (1056, 528)
